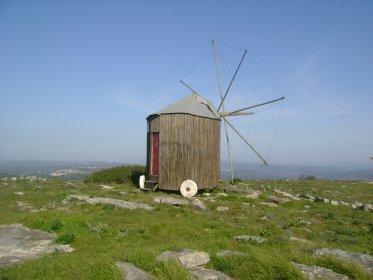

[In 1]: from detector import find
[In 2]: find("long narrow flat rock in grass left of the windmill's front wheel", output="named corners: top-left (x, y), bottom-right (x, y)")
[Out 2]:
top-left (62, 194), bottom-right (154, 210)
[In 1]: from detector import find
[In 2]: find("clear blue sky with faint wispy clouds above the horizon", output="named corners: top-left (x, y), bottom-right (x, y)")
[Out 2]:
top-left (0, 0), bottom-right (373, 167)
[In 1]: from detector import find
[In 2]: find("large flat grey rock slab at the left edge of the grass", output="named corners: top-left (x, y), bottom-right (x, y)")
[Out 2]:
top-left (0, 224), bottom-right (74, 267)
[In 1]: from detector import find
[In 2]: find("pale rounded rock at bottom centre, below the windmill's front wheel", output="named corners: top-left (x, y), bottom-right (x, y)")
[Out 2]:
top-left (157, 249), bottom-right (210, 269)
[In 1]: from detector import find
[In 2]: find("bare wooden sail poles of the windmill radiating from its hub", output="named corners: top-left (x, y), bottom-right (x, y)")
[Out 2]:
top-left (180, 40), bottom-right (285, 184)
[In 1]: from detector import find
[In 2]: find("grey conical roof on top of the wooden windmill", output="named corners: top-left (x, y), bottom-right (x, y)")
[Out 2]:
top-left (150, 93), bottom-right (220, 120)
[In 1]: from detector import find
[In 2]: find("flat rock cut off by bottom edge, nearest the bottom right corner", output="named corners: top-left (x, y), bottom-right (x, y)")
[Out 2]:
top-left (291, 262), bottom-right (349, 280)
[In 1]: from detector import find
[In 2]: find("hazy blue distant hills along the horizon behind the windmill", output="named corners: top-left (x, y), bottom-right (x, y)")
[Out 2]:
top-left (0, 161), bottom-right (373, 181)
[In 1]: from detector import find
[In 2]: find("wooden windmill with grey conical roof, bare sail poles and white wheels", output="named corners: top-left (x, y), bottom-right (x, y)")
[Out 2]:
top-left (139, 41), bottom-right (284, 197)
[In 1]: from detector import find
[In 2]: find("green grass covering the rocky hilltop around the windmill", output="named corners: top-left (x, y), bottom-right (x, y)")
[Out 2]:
top-left (0, 167), bottom-right (373, 280)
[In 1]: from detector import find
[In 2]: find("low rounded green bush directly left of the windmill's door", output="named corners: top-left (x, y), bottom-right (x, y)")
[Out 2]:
top-left (84, 165), bottom-right (145, 185)
